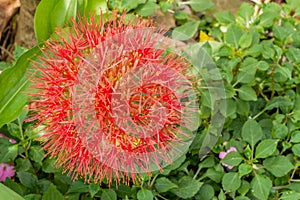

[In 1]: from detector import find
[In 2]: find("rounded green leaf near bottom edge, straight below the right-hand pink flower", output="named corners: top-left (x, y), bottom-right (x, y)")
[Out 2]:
top-left (222, 172), bottom-right (241, 192)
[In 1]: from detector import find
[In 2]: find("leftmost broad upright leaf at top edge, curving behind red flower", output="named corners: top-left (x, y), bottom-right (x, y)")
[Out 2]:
top-left (34, 0), bottom-right (59, 43)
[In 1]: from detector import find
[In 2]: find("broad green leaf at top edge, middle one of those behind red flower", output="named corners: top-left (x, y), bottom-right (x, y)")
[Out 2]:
top-left (46, 0), bottom-right (77, 30)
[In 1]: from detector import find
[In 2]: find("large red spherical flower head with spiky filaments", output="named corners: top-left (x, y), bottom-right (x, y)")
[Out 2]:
top-left (32, 14), bottom-right (198, 185)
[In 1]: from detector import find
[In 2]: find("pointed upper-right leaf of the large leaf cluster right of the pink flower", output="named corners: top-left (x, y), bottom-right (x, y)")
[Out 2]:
top-left (255, 139), bottom-right (278, 158)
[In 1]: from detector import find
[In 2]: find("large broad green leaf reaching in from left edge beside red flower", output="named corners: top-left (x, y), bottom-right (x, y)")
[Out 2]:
top-left (0, 47), bottom-right (40, 128)
